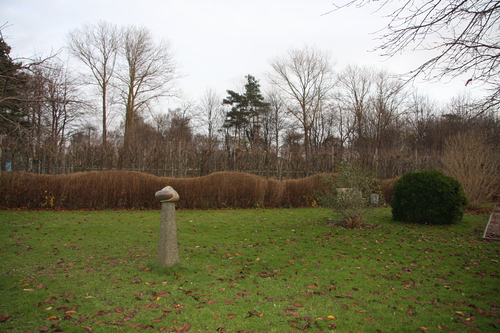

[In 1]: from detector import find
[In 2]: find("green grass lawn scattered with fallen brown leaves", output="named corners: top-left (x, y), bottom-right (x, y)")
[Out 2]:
top-left (0, 208), bottom-right (500, 332)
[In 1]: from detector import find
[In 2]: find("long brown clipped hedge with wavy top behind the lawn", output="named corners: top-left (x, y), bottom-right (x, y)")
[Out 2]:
top-left (0, 171), bottom-right (348, 209)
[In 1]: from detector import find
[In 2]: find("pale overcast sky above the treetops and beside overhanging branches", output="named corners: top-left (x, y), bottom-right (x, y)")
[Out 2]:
top-left (0, 0), bottom-right (473, 109)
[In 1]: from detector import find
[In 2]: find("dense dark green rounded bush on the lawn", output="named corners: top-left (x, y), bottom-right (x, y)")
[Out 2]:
top-left (391, 170), bottom-right (468, 224)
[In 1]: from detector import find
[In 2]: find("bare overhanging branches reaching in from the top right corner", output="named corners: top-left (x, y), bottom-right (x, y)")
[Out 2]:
top-left (330, 0), bottom-right (500, 107)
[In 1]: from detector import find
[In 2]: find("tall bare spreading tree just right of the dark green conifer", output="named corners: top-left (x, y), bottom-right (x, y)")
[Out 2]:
top-left (268, 46), bottom-right (335, 160)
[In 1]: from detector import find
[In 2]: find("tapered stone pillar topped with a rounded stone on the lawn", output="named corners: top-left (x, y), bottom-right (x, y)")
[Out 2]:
top-left (155, 186), bottom-right (179, 267)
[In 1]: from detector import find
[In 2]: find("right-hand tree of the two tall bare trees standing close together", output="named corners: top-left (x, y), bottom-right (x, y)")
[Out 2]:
top-left (119, 26), bottom-right (178, 147)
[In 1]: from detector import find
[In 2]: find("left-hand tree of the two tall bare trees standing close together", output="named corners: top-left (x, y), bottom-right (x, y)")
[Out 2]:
top-left (68, 21), bottom-right (122, 147)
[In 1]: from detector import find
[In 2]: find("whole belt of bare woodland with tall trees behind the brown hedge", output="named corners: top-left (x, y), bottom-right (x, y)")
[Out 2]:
top-left (0, 22), bottom-right (500, 187)
